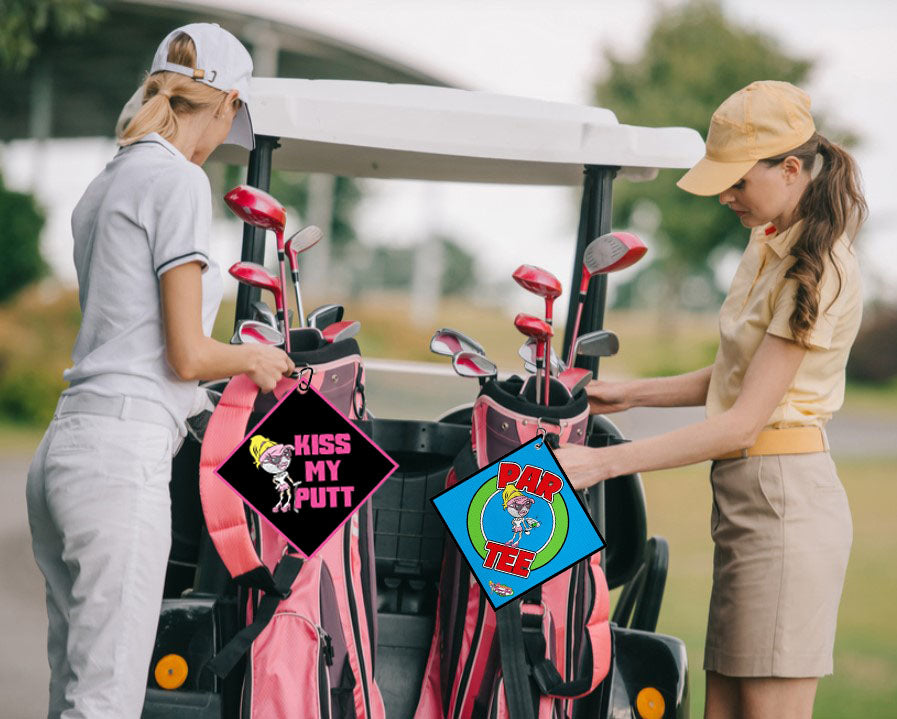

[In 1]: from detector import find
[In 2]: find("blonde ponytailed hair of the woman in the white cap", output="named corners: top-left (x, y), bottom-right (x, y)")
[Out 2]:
top-left (118, 33), bottom-right (240, 147)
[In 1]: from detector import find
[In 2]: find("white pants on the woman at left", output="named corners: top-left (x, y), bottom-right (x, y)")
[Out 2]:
top-left (27, 402), bottom-right (173, 719)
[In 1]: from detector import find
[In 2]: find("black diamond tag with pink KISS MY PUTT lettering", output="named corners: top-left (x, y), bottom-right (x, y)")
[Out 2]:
top-left (216, 387), bottom-right (398, 557)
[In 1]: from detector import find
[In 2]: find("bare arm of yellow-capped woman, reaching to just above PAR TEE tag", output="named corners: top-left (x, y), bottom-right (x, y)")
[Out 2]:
top-left (556, 334), bottom-right (807, 489)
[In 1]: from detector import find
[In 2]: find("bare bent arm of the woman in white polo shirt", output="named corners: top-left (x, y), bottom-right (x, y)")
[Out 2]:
top-left (160, 262), bottom-right (295, 392)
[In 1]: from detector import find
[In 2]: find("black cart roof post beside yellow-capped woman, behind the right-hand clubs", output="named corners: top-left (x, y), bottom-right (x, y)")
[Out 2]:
top-left (561, 165), bottom-right (619, 569)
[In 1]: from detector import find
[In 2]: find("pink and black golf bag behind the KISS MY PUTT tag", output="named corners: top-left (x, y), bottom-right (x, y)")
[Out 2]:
top-left (200, 330), bottom-right (385, 719)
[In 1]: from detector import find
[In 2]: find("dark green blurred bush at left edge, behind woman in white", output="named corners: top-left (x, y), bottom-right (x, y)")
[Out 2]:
top-left (0, 177), bottom-right (47, 302)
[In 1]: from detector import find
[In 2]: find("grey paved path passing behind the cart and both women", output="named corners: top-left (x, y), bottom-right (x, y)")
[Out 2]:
top-left (0, 371), bottom-right (897, 719)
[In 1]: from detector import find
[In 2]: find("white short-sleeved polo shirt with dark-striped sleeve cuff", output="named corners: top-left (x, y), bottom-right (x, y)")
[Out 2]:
top-left (63, 133), bottom-right (222, 436)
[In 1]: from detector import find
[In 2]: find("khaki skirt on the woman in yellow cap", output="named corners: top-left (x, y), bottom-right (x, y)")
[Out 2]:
top-left (704, 452), bottom-right (853, 677)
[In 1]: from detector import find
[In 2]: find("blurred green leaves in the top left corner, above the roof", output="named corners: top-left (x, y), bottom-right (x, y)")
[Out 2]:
top-left (0, 0), bottom-right (106, 71)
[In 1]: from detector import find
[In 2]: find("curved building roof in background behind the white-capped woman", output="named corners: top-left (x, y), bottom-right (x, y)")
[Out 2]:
top-left (0, 0), bottom-right (447, 141)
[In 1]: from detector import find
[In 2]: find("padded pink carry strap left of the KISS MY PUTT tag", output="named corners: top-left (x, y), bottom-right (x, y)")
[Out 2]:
top-left (199, 374), bottom-right (297, 595)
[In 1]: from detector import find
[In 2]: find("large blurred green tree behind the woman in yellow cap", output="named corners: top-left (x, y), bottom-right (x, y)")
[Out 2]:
top-left (595, 0), bottom-right (840, 310)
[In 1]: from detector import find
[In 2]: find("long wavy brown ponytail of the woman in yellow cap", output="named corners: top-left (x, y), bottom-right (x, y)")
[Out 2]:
top-left (763, 133), bottom-right (868, 347)
